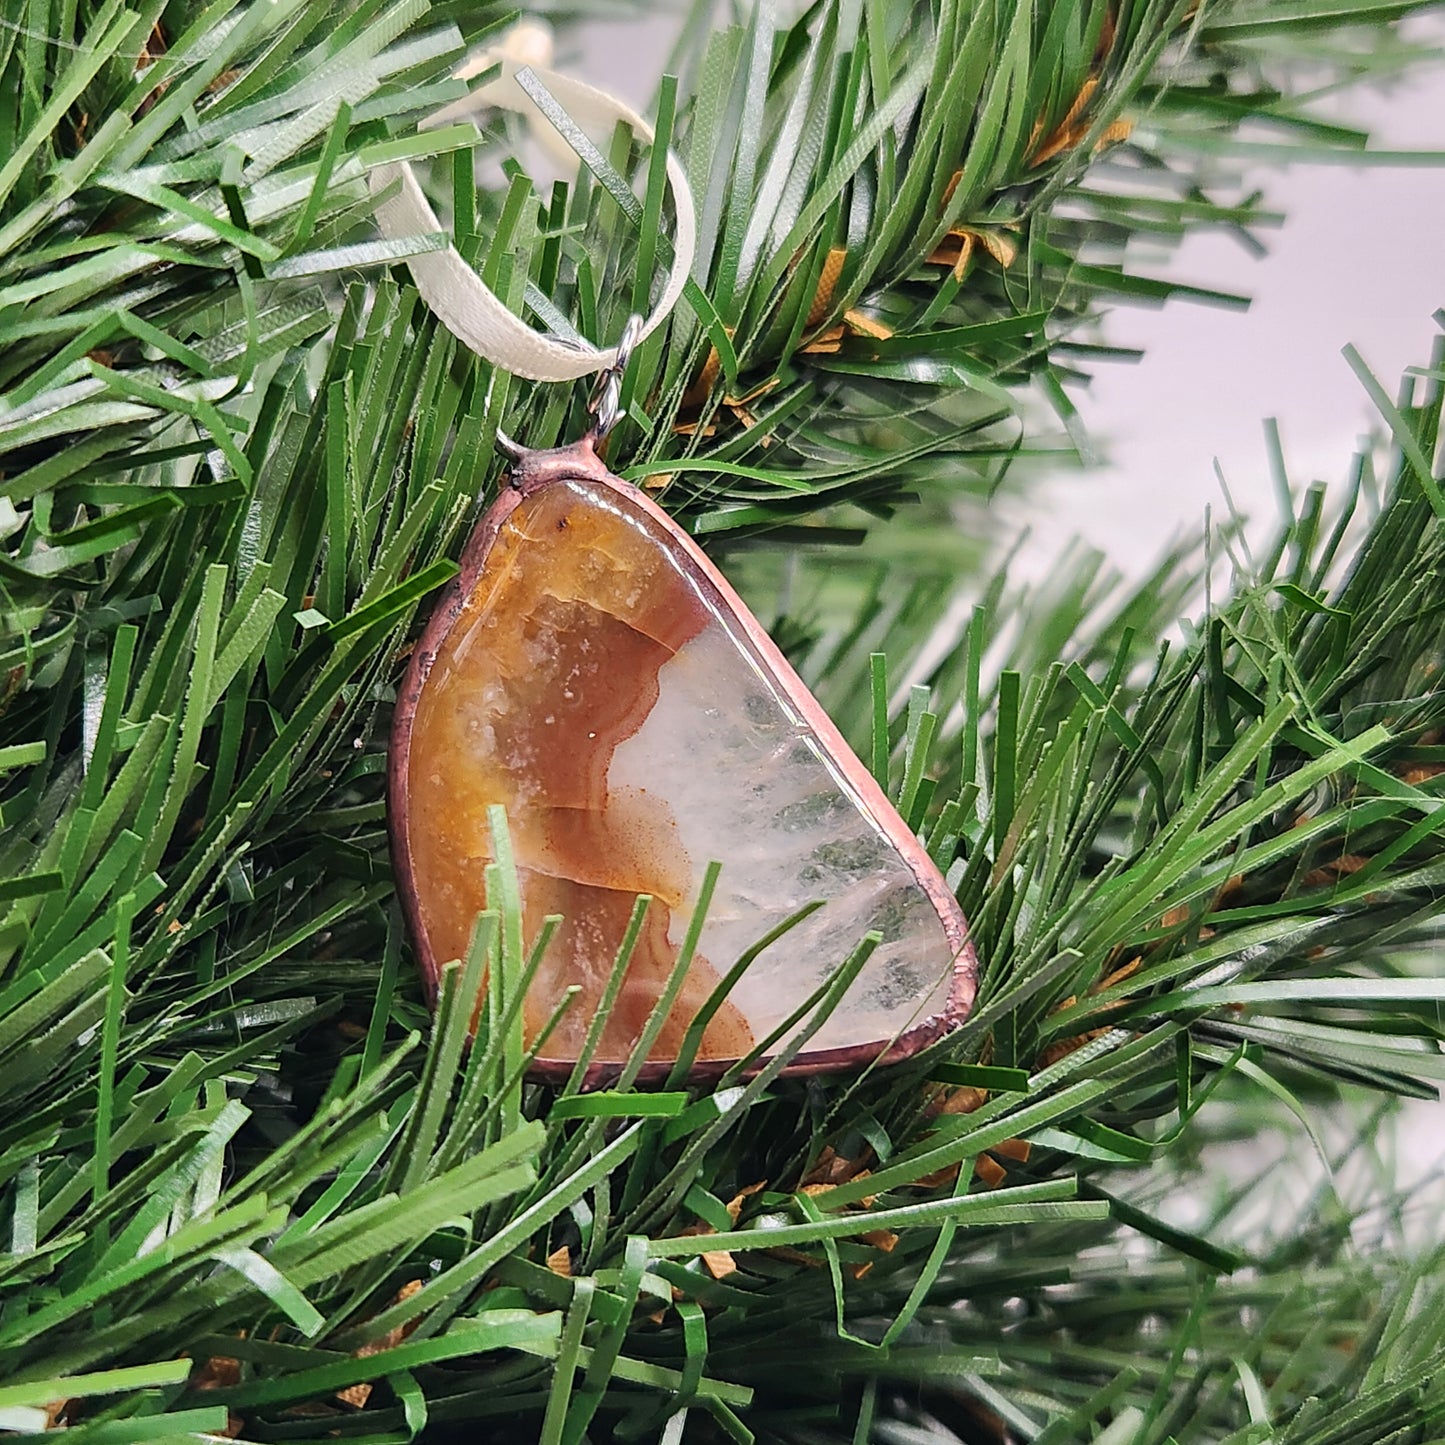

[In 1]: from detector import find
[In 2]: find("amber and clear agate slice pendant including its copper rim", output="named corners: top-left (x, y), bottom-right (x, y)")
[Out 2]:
top-left (390, 441), bottom-right (977, 1082)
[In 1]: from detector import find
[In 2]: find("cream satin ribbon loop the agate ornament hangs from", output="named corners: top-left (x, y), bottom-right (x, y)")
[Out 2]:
top-left (371, 23), bottom-right (696, 381)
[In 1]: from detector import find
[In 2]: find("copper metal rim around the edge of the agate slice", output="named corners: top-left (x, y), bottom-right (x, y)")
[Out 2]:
top-left (387, 438), bottom-right (978, 1088)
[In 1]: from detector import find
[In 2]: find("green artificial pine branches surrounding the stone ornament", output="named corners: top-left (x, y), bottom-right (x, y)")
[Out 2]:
top-left (0, 0), bottom-right (1445, 1445)
